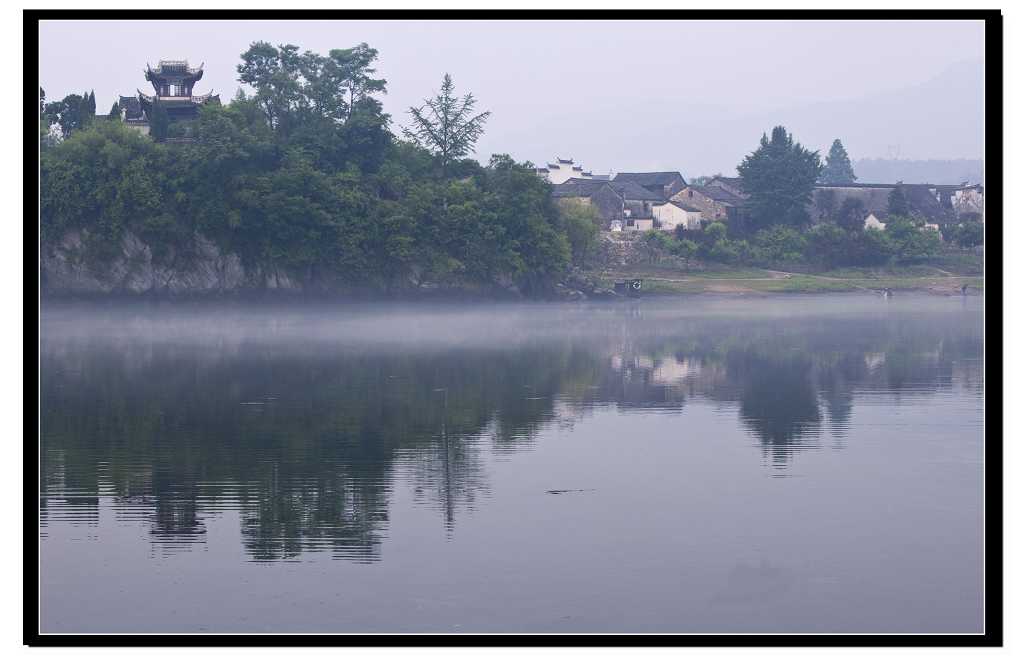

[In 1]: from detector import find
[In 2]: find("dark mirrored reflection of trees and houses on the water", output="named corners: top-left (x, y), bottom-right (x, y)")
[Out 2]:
top-left (40, 304), bottom-right (983, 562)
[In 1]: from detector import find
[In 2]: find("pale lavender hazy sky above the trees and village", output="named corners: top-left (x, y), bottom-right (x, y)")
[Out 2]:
top-left (40, 20), bottom-right (984, 177)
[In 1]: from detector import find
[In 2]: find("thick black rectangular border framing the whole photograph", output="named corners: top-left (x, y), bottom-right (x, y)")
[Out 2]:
top-left (23, 9), bottom-right (1004, 647)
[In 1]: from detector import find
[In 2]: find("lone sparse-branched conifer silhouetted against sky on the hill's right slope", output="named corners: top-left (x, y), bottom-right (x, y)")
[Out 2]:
top-left (402, 74), bottom-right (490, 178)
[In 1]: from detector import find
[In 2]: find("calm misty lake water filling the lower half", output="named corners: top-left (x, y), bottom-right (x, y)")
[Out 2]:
top-left (39, 295), bottom-right (984, 632)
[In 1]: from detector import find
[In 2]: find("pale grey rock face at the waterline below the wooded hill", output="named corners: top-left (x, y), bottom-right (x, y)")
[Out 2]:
top-left (40, 231), bottom-right (260, 295)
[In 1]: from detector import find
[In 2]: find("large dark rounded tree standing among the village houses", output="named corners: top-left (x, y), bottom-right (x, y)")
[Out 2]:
top-left (736, 126), bottom-right (821, 228)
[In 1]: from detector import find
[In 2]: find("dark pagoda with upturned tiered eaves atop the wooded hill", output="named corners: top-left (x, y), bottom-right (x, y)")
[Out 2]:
top-left (118, 60), bottom-right (220, 134)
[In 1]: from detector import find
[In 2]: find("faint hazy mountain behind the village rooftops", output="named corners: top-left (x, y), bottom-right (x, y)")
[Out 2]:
top-left (516, 60), bottom-right (985, 177)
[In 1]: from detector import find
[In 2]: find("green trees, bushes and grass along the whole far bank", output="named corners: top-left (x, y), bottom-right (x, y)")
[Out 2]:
top-left (39, 42), bottom-right (984, 300)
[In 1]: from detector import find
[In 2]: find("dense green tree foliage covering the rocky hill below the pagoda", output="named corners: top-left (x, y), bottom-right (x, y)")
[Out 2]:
top-left (42, 42), bottom-right (577, 293)
